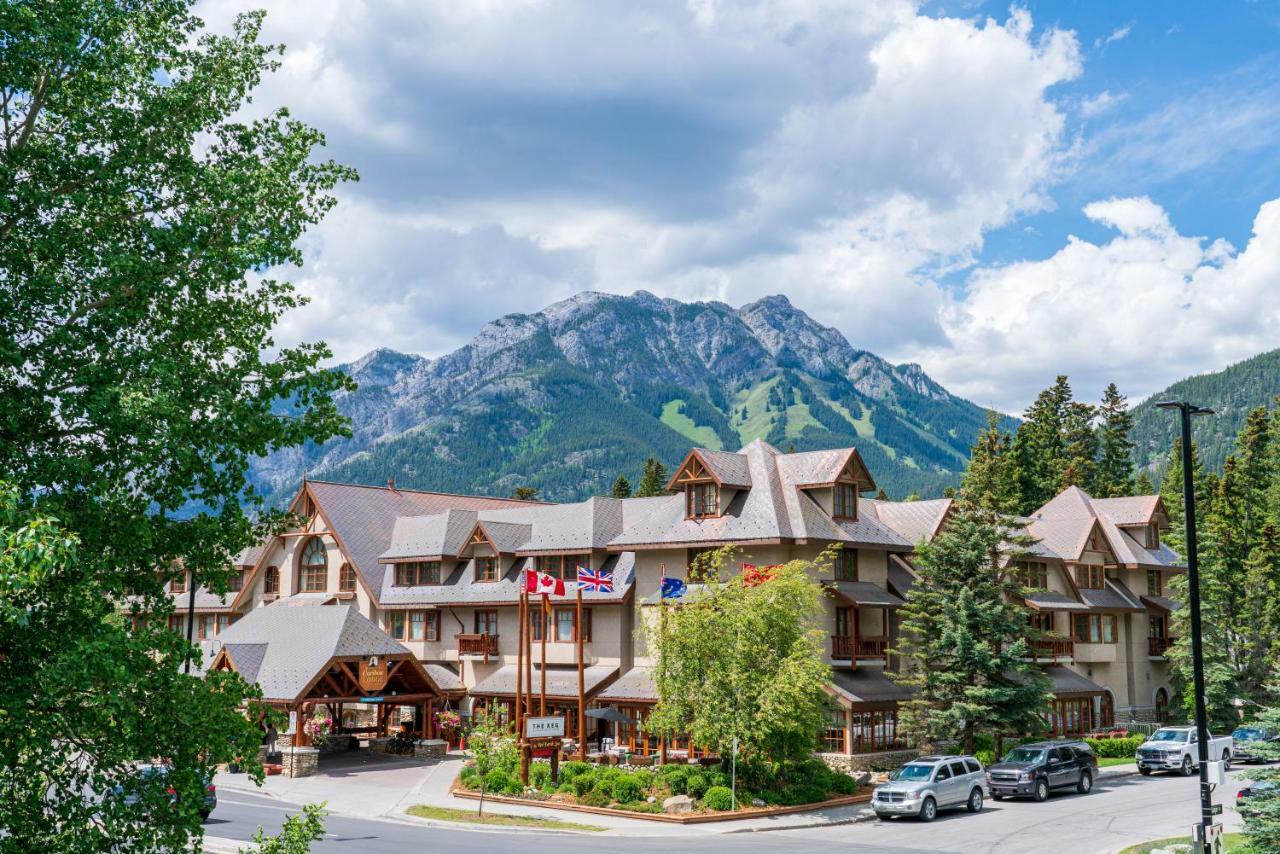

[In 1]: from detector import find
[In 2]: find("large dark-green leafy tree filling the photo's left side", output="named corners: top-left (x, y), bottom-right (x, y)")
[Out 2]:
top-left (0, 0), bottom-right (353, 851)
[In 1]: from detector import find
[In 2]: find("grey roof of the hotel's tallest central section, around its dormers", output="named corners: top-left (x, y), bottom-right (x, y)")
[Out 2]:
top-left (609, 439), bottom-right (913, 552)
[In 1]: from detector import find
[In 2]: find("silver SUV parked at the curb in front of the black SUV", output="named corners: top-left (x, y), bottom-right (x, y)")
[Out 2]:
top-left (872, 757), bottom-right (987, 822)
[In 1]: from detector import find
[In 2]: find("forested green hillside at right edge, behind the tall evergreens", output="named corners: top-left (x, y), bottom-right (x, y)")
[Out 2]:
top-left (1133, 350), bottom-right (1280, 475)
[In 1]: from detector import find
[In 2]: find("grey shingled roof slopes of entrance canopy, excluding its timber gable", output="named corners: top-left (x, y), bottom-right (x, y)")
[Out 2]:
top-left (207, 604), bottom-right (412, 702)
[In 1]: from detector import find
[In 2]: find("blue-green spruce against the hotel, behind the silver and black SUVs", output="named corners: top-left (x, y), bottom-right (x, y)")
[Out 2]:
top-left (893, 501), bottom-right (1050, 753)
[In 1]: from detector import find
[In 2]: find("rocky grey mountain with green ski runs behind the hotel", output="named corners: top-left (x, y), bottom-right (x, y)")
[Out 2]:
top-left (255, 291), bottom-right (1013, 501)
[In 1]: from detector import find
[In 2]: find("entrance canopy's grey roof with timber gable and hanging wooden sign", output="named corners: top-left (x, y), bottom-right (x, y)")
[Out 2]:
top-left (209, 604), bottom-right (440, 707)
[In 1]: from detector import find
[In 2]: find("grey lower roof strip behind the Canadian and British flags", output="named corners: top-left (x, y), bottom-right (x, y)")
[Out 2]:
top-left (378, 552), bottom-right (635, 609)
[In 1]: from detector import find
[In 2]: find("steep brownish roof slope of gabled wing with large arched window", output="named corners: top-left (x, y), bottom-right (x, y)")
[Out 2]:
top-left (305, 480), bottom-right (541, 599)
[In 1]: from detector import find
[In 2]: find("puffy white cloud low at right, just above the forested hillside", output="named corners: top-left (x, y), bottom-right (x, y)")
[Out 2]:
top-left (922, 197), bottom-right (1280, 411)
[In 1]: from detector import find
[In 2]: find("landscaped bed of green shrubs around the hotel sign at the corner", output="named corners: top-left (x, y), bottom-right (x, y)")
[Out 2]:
top-left (458, 759), bottom-right (858, 816)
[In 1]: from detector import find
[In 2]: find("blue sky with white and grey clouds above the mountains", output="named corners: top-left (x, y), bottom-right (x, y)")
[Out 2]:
top-left (197, 0), bottom-right (1280, 412)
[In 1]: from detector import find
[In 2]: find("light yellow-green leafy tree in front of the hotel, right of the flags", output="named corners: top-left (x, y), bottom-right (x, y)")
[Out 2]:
top-left (644, 548), bottom-right (832, 762)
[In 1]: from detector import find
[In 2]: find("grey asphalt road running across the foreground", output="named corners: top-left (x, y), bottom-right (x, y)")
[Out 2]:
top-left (205, 776), bottom-right (1242, 854)
